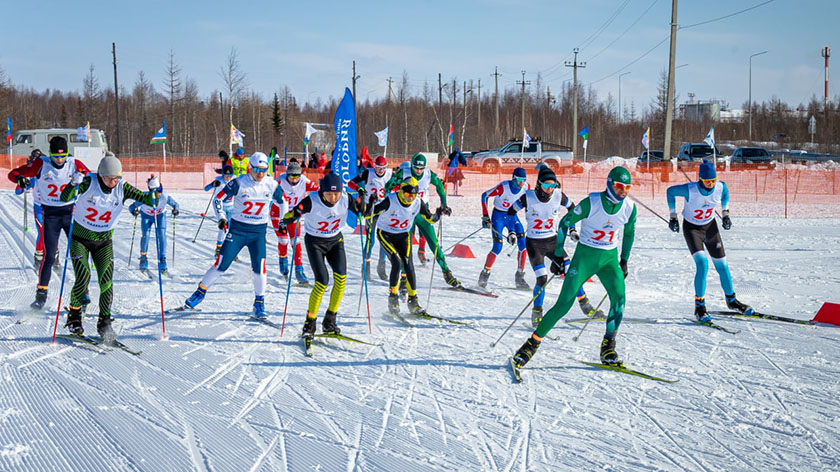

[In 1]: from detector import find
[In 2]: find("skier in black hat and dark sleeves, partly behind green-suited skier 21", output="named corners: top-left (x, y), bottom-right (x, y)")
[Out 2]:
top-left (507, 166), bottom-right (604, 328)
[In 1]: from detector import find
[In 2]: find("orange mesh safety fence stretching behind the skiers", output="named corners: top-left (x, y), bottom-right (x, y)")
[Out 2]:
top-left (0, 156), bottom-right (840, 218)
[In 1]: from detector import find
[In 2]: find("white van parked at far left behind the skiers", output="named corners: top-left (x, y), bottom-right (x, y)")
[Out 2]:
top-left (12, 128), bottom-right (108, 169)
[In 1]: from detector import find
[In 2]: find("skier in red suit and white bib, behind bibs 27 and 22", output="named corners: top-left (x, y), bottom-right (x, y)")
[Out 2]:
top-left (271, 162), bottom-right (319, 285)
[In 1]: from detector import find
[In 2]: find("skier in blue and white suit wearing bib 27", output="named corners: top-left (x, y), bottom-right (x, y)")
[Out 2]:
top-left (184, 152), bottom-right (286, 318)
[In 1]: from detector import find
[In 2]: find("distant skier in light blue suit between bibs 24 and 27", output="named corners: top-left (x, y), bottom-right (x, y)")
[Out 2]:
top-left (129, 174), bottom-right (181, 275)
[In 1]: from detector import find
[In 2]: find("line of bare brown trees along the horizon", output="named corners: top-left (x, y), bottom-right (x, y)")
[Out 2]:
top-left (0, 48), bottom-right (840, 158)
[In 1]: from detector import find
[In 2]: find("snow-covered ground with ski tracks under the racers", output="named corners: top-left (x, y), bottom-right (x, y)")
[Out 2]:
top-left (0, 191), bottom-right (840, 471)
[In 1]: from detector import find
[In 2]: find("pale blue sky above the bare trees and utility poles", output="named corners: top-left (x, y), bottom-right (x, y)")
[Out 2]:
top-left (0, 0), bottom-right (840, 110)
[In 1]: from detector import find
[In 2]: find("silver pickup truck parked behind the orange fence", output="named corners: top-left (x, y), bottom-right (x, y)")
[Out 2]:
top-left (472, 141), bottom-right (574, 173)
